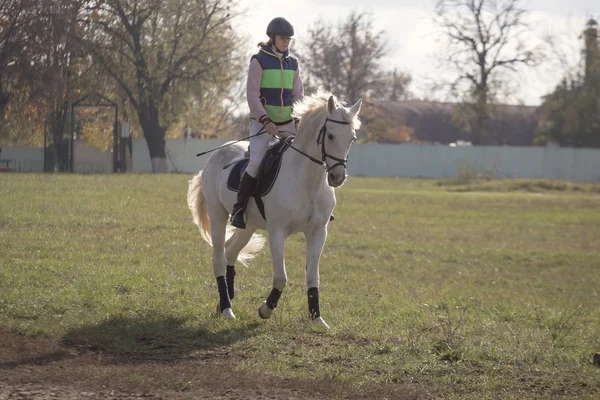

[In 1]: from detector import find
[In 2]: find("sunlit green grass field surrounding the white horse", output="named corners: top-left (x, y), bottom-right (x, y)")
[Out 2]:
top-left (0, 174), bottom-right (600, 399)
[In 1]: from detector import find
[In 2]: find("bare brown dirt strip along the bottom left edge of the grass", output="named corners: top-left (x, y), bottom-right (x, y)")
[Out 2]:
top-left (0, 331), bottom-right (414, 400)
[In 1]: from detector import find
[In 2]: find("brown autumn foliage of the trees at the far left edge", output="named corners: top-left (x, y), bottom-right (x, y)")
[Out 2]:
top-left (0, 0), bottom-right (94, 169)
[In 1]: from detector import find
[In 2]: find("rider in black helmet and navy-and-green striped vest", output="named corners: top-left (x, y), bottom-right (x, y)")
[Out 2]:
top-left (231, 17), bottom-right (304, 229)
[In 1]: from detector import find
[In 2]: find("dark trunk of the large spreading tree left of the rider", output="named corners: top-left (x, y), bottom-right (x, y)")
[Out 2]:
top-left (138, 105), bottom-right (168, 173)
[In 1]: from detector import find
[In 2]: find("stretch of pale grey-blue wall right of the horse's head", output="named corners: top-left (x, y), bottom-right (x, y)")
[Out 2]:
top-left (348, 144), bottom-right (600, 182)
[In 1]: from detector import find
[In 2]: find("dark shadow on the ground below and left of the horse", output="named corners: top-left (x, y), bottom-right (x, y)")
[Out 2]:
top-left (62, 316), bottom-right (260, 362)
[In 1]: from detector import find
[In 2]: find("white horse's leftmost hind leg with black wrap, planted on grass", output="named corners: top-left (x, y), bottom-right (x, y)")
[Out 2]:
top-left (209, 208), bottom-right (235, 319)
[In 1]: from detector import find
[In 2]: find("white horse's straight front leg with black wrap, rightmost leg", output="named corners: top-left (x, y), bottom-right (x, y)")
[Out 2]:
top-left (305, 227), bottom-right (329, 329)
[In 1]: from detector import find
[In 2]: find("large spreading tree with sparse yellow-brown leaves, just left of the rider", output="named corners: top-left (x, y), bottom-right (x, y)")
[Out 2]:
top-left (85, 0), bottom-right (241, 172)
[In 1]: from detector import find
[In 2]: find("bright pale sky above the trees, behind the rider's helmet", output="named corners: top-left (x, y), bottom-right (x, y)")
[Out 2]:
top-left (234, 0), bottom-right (600, 105)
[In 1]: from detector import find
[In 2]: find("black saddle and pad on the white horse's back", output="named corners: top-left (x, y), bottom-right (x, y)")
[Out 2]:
top-left (223, 136), bottom-right (293, 220)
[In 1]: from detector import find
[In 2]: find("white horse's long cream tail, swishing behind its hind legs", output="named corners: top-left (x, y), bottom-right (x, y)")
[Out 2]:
top-left (187, 171), bottom-right (265, 266)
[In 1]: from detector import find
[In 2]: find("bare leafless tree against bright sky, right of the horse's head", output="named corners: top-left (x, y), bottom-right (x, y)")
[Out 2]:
top-left (435, 0), bottom-right (542, 144)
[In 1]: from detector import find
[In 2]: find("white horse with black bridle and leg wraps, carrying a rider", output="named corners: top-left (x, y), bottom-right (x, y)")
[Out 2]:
top-left (187, 93), bottom-right (362, 327)
